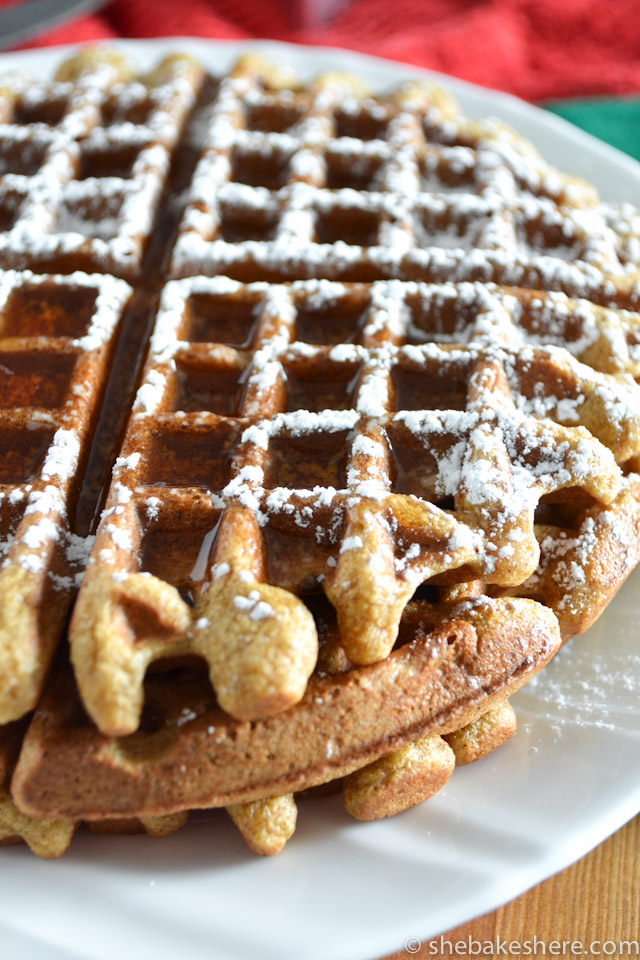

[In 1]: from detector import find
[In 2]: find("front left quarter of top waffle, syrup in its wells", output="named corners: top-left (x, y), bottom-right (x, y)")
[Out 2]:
top-left (0, 271), bottom-right (131, 723)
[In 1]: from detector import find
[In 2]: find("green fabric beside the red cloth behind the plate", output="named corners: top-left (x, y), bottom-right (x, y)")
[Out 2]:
top-left (542, 97), bottom-right (640, 160)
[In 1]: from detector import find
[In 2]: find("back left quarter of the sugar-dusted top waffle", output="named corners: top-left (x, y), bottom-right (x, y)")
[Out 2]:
top-left (0, 50), bottom-right (203, 278)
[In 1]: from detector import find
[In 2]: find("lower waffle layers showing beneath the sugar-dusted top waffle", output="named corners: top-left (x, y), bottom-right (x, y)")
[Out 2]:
top-left (0, 477), bottom-right (640, 857)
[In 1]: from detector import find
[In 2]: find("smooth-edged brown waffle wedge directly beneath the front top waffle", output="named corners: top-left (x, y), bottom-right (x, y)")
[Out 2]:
top-left (13, 596), bottom-right (560, 819)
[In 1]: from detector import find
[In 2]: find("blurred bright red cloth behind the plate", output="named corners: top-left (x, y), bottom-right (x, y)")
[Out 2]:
top-left (5, 0), bottom-right (640, 100)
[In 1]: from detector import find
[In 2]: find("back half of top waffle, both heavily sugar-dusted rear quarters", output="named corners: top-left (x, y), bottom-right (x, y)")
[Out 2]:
top-left (0, 51), bottom-right (640, 300)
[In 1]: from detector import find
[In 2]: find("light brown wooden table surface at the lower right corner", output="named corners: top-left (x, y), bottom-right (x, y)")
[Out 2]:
top-left (385, 816), bottom-right (640, 960)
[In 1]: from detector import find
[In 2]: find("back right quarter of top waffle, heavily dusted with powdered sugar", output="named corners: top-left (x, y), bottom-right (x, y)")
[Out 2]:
top-left (172, 57), bottom-right (640, 303)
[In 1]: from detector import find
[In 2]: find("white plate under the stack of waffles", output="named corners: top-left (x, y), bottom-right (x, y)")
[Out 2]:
top-left (0, 39), bottom-right (640, 960)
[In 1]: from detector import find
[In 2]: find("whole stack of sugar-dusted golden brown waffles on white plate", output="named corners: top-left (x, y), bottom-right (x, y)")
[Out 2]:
top-left (0, 51), bottom-right (640, 857)
